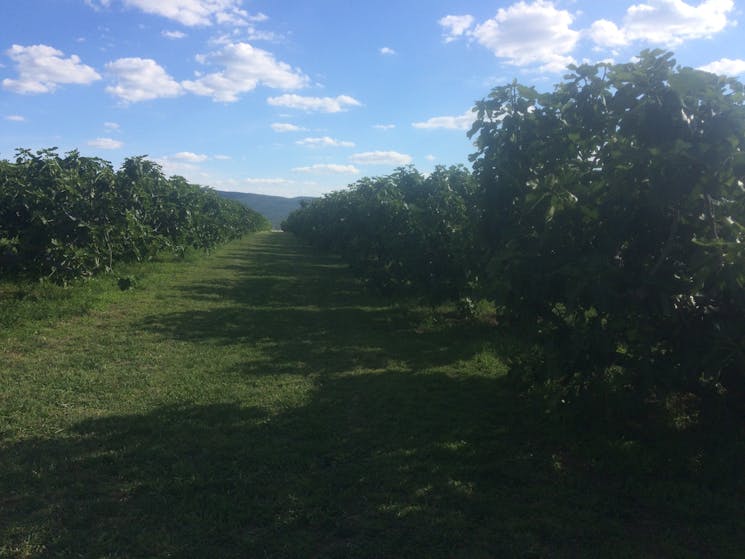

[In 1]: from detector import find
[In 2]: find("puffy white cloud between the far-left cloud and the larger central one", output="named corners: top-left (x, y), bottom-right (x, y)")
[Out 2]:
top-left (106, 58), bottom-right (183, 103)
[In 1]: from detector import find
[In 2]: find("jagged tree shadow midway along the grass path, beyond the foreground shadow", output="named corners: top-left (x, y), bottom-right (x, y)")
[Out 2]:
top-left (142, 234), bottom-right (500, 374)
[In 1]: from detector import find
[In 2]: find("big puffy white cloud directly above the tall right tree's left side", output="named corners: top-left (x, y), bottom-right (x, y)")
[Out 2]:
top-left (467, 0), bottom-right (580, 72)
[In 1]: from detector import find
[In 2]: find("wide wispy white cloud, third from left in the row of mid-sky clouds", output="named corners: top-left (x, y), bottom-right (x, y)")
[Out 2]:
top-left (182, 43), bottom-right (309, 103)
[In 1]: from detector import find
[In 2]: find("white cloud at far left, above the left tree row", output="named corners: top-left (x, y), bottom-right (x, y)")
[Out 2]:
top-left (3, 45), bottom-right (101, 94)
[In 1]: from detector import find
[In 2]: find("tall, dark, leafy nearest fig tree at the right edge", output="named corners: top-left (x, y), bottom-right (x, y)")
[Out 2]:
top-left (471, 51), bottom-right (745, 442)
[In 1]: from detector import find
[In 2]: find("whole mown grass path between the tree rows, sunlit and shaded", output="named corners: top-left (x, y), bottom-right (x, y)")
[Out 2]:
top-left (0, 233), bottom-right (745, 559)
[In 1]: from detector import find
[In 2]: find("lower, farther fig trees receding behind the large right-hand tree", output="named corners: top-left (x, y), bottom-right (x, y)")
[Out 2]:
top-left (283, 167), bottom-right (480, 300)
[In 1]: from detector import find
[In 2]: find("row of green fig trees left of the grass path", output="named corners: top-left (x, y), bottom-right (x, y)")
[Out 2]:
top-left (0, 148), bottom-right (269, 282)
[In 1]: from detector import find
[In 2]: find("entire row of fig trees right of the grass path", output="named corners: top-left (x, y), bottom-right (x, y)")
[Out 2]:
top-left (286, 51), bottom-right (745, 468)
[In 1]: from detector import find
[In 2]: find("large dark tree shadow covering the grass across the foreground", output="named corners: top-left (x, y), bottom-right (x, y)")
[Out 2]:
top-left (0, 373), bottom-right (743, 559)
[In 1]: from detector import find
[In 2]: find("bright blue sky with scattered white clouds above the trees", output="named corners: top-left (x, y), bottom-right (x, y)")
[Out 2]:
top-left (0, 0), bottom-right (745, 196)
